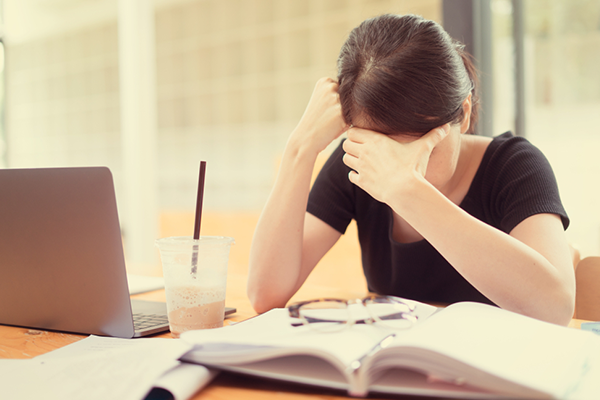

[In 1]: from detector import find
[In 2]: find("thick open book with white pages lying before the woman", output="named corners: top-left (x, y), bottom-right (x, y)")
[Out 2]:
top-left (182, 302), bottom-right (600, 399)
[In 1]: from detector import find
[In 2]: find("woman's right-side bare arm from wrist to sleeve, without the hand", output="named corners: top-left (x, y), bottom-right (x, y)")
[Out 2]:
top-left (392, 182), bottom-right (575, 325)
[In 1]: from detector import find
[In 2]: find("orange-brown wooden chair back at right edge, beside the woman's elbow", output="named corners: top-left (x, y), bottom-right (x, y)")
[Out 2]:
top-left (575, 257), bottom-right (600, 321)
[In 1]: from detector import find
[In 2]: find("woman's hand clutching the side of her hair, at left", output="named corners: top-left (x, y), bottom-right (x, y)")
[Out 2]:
top-left (292, 78), bottom-right (348, 153)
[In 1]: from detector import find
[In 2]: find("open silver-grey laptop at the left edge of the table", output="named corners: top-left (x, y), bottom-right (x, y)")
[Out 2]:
top-left (0, 167), bottom-right (233, 338)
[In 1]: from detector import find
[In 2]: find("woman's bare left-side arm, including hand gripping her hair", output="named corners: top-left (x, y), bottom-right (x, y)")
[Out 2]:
top-left (248, 78), bottom-right (347, 313)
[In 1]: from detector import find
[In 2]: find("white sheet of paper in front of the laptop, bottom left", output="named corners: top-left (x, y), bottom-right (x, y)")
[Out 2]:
top-left (0, 336), bottom-right (190, 400)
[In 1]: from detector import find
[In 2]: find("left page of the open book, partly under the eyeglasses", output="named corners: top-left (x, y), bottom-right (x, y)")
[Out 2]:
top-left (182, 302), bottom-right (437, 371)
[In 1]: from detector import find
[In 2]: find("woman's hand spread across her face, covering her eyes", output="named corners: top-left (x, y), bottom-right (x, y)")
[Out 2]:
top-left (343, 124), bottom-right (450, 204)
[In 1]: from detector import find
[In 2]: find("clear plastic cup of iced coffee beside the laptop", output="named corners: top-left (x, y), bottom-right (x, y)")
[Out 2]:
top-left (156, 236), bottom-right (234, 338)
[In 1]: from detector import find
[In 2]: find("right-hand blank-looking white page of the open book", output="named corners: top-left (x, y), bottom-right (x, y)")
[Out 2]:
top-left (371, 303), bottom-right (600, 398)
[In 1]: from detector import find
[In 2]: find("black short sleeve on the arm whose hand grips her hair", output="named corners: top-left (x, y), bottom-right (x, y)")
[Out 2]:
top-left (307, 141), bottom-right (356, 234)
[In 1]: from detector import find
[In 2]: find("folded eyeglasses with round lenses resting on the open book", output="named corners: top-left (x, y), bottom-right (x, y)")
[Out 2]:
top-left (288, 295), bottom-right (418, 332)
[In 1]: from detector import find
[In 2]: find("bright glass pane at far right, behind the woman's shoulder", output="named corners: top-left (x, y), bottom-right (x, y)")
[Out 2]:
top-left (524, 0), bottom-right (600, 256)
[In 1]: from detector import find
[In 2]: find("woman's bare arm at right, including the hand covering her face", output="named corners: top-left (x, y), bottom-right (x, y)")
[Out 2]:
top-left (344, 126), bottom-right (575, 325)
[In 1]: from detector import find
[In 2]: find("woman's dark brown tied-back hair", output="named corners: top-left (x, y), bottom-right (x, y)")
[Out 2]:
top-left (338, 14), bottom-right (479, 135)
